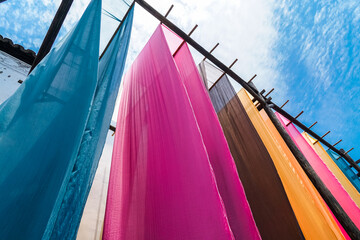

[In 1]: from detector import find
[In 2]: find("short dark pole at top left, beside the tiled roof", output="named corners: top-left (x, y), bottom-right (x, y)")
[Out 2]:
top-left (29, 0), bottom-right (73, 74)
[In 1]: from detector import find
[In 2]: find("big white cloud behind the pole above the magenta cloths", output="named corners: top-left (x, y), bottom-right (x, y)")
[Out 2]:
top-left (109, 0), bottom-right (287, 120)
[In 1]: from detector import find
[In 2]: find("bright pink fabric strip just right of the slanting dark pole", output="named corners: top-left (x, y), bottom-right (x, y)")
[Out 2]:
top-left (276, 113), bottom-right (360, 229)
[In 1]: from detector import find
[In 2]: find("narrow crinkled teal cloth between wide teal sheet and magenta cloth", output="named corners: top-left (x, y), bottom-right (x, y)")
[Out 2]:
top-left (49, 8), bottom-right (133, 240)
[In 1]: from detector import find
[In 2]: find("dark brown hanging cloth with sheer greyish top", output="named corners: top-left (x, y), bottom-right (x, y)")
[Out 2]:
top-left (202, 69), bottom-right (303, 239)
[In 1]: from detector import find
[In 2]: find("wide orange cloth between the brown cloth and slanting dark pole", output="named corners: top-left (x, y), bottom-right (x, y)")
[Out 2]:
top-left (238, 89), bottom-right (345, 239)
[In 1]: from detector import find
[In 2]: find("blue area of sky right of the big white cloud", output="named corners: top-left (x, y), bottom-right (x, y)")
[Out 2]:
top-left (274, 0), bottom-right (360, 160)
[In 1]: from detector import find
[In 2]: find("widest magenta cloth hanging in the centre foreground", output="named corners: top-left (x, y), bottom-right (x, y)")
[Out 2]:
top-left (103, 26), bottom-right (234, 240)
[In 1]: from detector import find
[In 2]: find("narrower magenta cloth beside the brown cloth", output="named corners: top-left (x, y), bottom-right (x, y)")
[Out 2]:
top-left (173, 32), bottom-right (260, 239)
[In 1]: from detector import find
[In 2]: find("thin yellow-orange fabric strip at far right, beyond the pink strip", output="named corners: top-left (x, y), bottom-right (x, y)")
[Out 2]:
top-left (302, 132), bottom-right (360, 209)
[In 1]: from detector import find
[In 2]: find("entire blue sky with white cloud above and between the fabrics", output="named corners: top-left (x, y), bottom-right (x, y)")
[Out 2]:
top-left (0, 0), bottom-right (360, 160)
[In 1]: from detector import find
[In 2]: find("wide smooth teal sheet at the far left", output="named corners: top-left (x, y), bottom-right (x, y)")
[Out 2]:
top-left (0, 0), bottom-right (101, 240)
